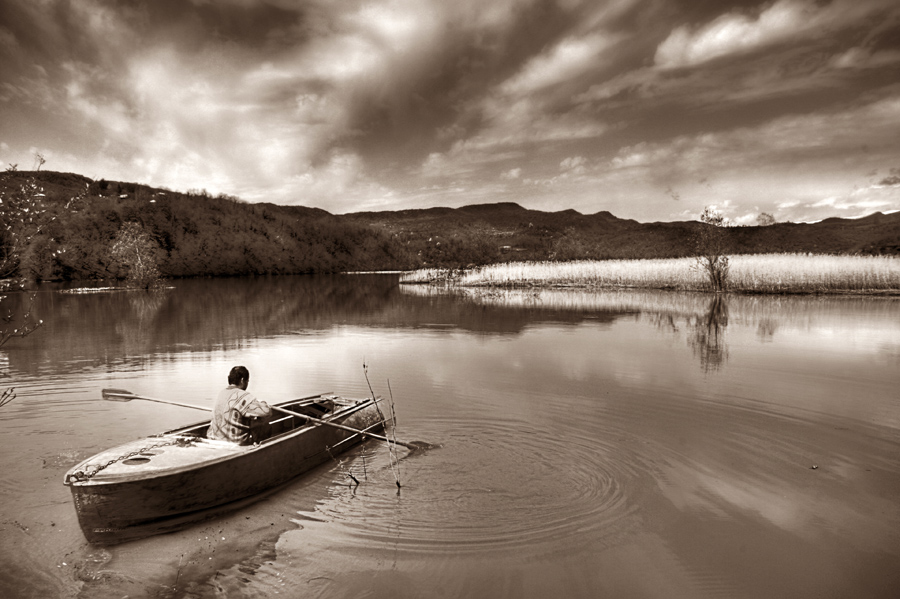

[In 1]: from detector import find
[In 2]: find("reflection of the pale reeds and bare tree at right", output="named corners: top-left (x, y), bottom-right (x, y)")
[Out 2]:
top-left (401, 285), bottom-right (900, 372)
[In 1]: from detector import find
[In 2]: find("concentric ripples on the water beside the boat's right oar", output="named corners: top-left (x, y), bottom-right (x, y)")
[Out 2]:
top-left (306, 420), bottom-right (637, 551)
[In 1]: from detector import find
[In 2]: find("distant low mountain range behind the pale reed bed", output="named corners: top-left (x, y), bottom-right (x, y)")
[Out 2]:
top-left (342, 203), bottom-right (900, 259)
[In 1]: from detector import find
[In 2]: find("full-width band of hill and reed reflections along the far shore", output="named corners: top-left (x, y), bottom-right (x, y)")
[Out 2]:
top-left (4, 275), bottom-right (898, 375)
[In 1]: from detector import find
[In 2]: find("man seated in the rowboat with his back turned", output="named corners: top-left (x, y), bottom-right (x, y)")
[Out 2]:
top-left (206, 366), bottom-right (272, 445)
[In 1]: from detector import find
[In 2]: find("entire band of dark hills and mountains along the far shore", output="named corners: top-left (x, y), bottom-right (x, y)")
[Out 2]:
top-left (0, 171), bottom-right (900, 280)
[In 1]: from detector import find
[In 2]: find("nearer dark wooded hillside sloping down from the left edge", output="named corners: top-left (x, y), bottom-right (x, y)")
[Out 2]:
top-left (3, 172), bottom-right (413, 280)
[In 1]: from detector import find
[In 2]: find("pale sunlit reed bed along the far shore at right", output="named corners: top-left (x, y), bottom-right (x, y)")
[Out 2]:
top-left (401, 254), bottom-right (900, 293)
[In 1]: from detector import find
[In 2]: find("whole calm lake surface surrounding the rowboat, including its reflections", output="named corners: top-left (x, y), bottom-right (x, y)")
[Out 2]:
top-left (0, 275), bottom-right (900, 599)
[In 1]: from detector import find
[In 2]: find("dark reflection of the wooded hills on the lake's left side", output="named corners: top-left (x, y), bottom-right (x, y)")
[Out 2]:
top-left (4, 275), bottom-right (620, 376)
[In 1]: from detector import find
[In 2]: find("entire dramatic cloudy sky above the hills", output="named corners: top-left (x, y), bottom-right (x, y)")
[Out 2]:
top-left (0, 0), bottom-right (900, 224)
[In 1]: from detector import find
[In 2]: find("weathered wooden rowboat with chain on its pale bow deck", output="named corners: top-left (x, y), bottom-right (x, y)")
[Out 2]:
top-left (64, 395), bottom-right (385, 545)
